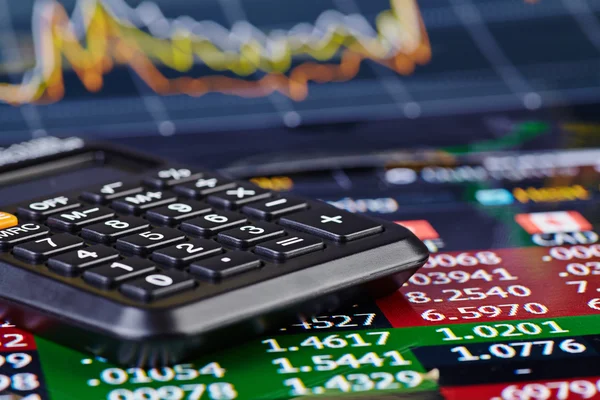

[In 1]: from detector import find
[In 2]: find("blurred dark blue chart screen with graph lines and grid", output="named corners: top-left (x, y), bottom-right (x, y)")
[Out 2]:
top-left (0, 0), bottom-right (600, 140)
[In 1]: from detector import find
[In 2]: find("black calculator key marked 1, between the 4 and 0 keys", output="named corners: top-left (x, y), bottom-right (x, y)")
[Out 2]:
top-left (83, 257), bottom-right (156, 289)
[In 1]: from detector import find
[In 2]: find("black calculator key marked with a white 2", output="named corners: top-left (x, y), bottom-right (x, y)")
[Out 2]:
top-left (152, 239), bottom-right (223, 267)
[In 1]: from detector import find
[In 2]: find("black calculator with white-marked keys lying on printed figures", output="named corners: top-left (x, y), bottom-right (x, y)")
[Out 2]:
top-left (0, 141), bottom-right (428, 366)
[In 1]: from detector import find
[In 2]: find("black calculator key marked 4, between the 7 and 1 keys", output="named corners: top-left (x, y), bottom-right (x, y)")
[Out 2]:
top-left (48, 244), bottom-right (119, 275)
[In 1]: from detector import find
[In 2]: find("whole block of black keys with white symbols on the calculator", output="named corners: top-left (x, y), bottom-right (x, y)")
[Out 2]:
top-left (0, 168), bottom-right (390, 302)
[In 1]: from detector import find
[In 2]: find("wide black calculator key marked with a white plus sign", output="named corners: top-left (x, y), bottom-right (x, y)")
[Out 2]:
top-left (279, 208), bottom-right (383, 242)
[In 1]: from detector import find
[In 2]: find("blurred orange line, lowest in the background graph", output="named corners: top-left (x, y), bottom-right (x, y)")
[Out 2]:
top-left (0, 0), bottom-right (431, 105)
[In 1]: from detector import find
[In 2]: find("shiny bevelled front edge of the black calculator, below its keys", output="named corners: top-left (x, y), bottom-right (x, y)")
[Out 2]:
top-left (0, 236), bottom-right (429, 367)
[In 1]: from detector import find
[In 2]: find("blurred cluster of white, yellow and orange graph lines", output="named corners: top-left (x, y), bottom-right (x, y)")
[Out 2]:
top-left (0, 0), bottom-right (431, 105)
